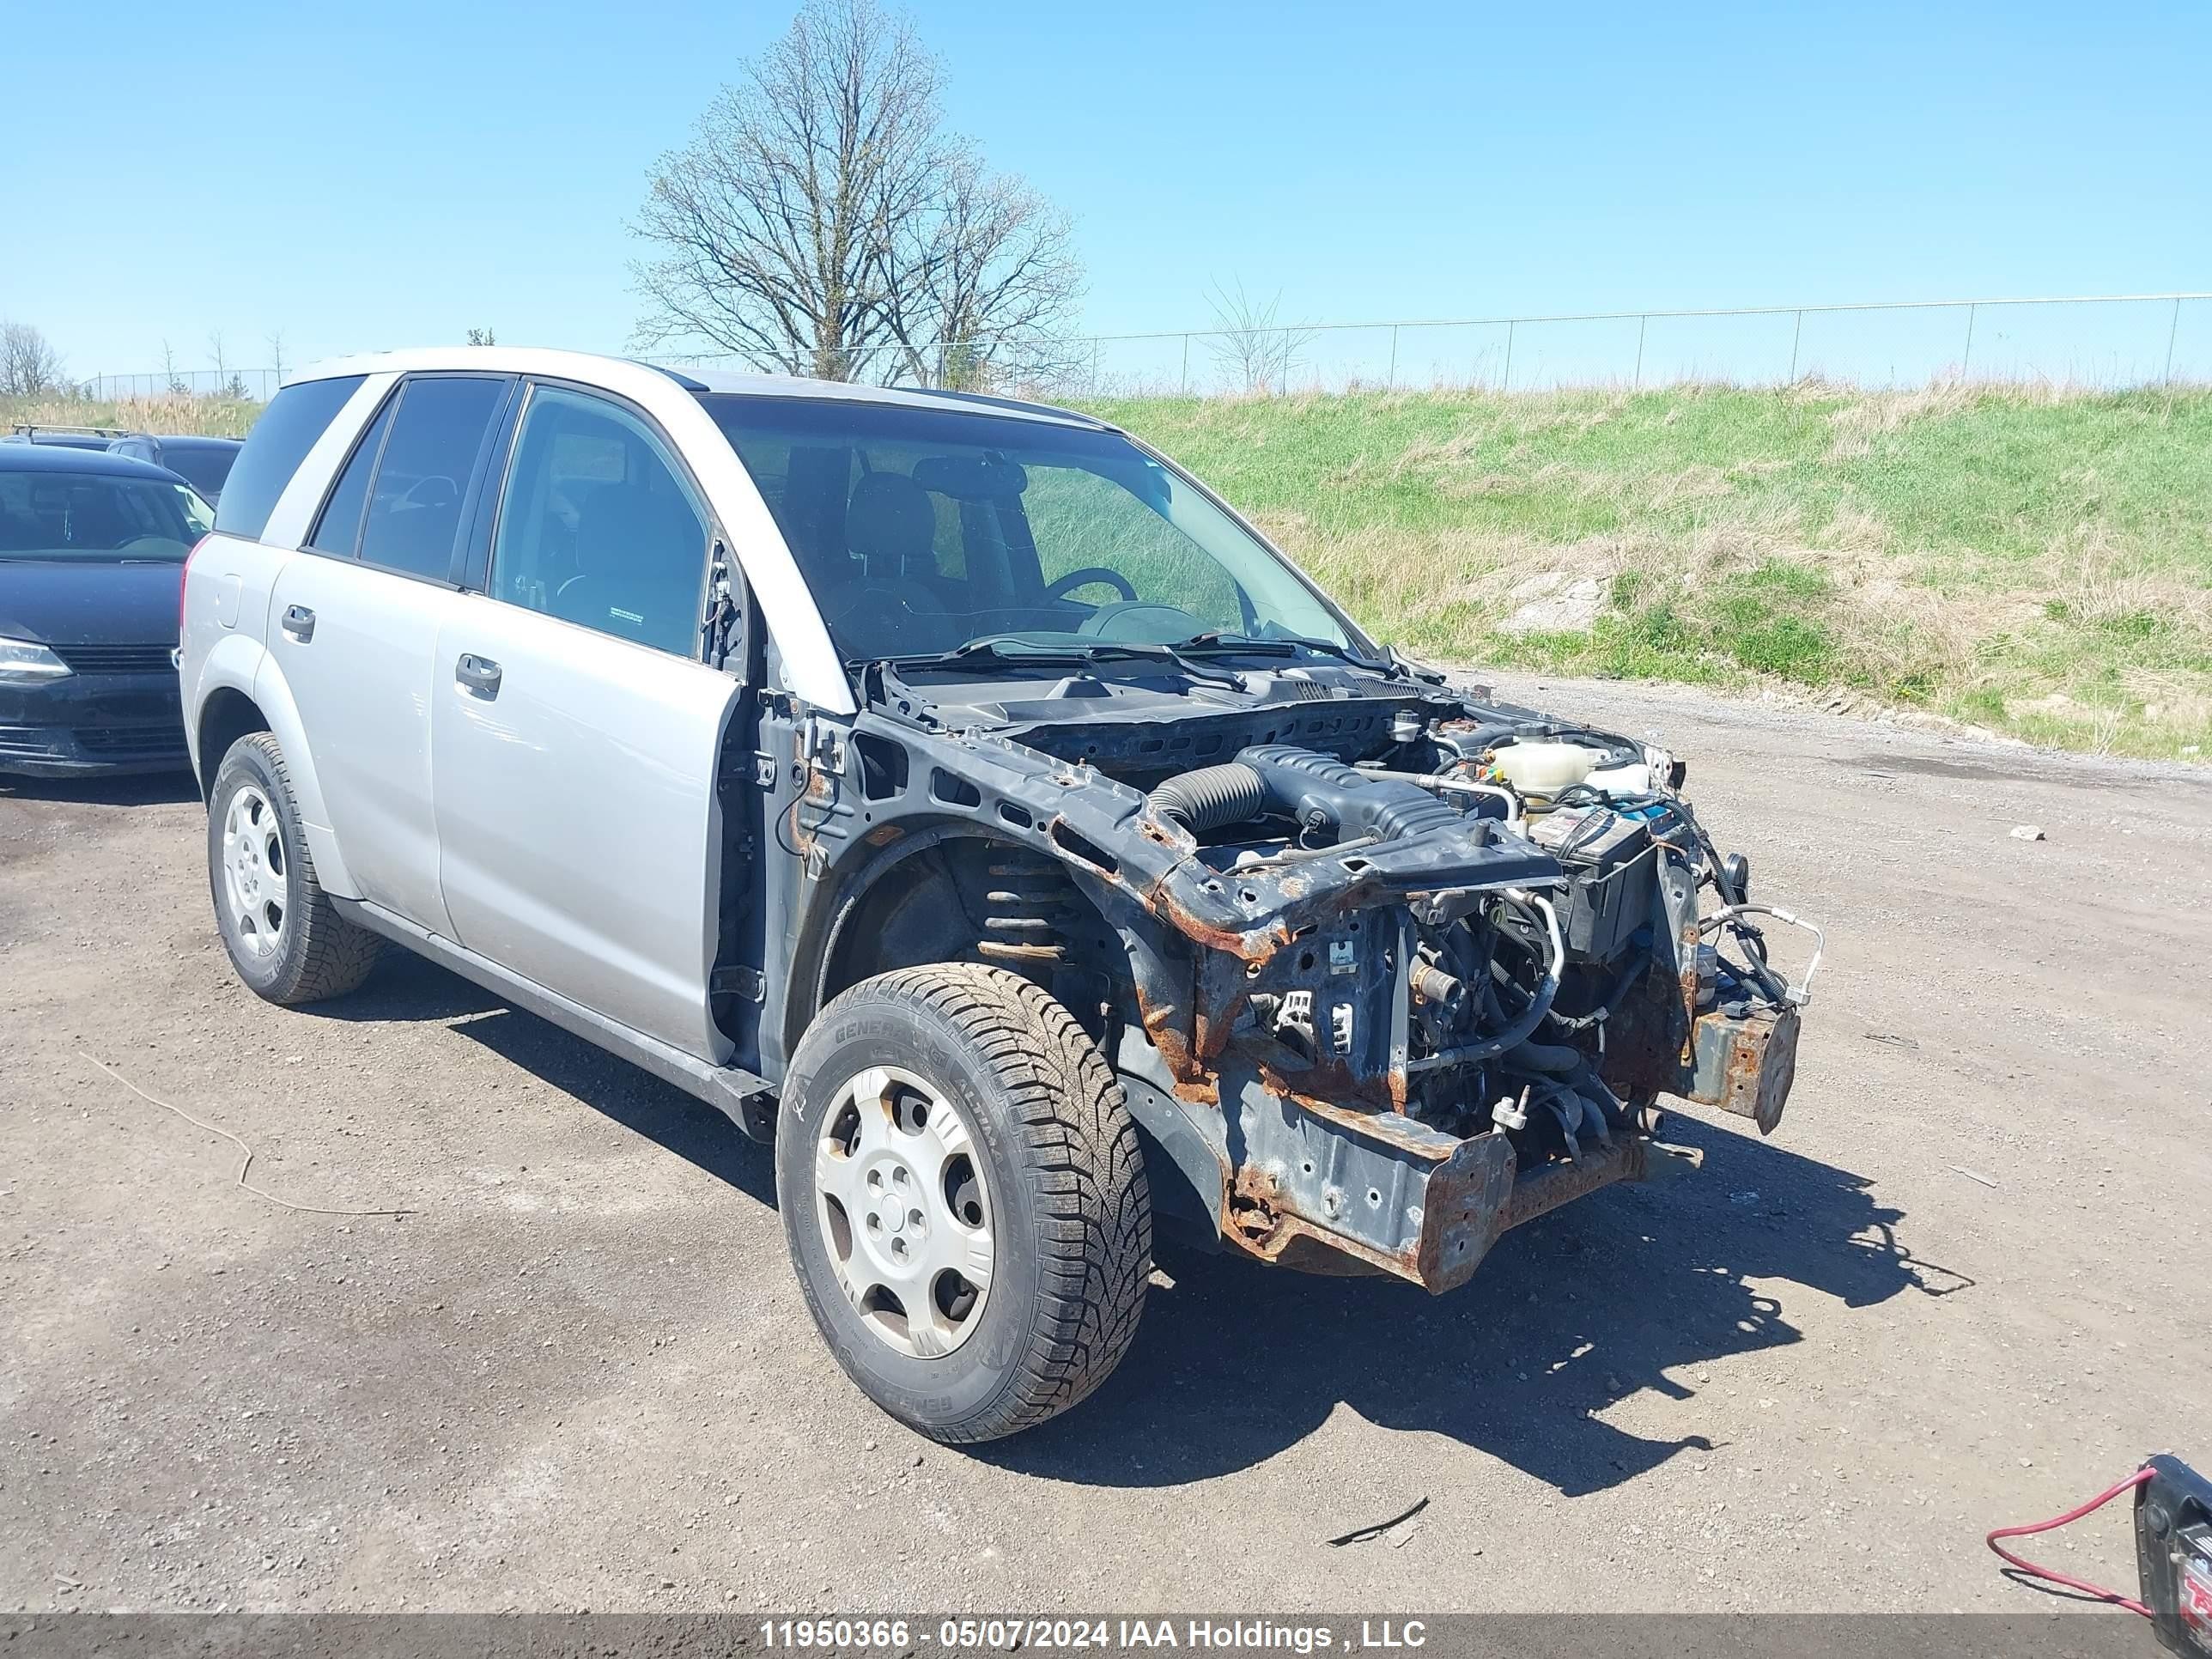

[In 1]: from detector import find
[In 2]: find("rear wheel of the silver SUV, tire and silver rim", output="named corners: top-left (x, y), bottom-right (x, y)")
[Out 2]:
top-left (208, 732), bottom-right (383, 1005)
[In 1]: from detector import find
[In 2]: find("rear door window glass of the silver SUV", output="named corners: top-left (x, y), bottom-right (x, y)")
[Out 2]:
top-left (354, 378), bottom-right (507, 581)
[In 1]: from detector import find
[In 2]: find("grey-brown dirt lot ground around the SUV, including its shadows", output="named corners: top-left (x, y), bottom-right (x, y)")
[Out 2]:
top-left (0, 686), bottom-right (2212, 1613)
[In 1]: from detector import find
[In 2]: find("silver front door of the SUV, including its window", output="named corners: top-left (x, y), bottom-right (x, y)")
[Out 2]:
top-left (431, 385), bottom-right (738, 1060)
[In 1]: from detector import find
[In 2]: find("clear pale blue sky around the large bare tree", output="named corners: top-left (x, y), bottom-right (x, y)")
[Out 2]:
top-left (0, 0), bottom-right (2212, 374)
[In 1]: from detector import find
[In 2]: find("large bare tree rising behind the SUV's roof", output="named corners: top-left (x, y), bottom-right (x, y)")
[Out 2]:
top-left (633, 0), bottom-right (1078, 380)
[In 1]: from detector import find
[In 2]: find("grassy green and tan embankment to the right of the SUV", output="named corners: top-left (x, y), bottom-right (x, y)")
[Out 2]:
top-left (1091, 385), bottom-right (2212, 757)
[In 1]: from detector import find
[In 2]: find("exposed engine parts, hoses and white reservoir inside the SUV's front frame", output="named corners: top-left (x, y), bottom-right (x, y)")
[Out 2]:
top-left (1148, 719), bottom-right (1805, 1203)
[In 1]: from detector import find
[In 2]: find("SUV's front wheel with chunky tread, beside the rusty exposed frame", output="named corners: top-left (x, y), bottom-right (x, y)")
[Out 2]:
top-left (776, 964), bottom-right (1152, 1443)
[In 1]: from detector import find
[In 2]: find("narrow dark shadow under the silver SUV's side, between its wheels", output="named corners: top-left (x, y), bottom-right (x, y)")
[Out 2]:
top-left (301, 949), bottom-right (776, 1207)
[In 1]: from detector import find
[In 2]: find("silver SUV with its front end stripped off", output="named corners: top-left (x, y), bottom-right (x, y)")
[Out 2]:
top-left (179, 347), bottom-right (1818, 1440)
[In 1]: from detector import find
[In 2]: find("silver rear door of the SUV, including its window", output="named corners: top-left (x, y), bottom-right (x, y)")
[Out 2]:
top-left (268, 374), bottom-right (514, 938)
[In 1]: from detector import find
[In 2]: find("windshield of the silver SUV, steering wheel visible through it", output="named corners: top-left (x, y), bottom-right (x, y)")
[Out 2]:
top-left (702, 394), bottom-right (1356, 661)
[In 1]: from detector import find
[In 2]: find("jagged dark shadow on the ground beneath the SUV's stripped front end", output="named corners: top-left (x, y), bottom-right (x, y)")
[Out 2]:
top-left (975, 1117), bottom-right (1971, 1502)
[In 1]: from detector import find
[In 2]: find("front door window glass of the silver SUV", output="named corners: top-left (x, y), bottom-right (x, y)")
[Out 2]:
top-left (491, 387), bottom-right (708, 657)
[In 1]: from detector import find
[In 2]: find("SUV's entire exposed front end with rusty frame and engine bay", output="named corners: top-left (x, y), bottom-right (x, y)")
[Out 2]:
top-left (792, 664), bottom-right (1818, 1290)
